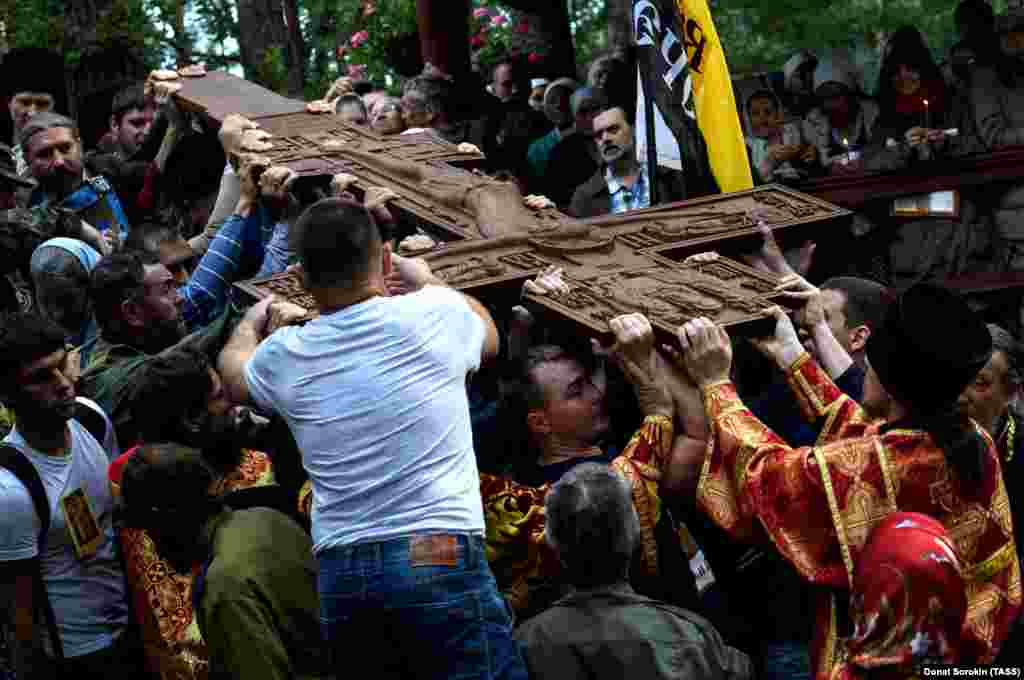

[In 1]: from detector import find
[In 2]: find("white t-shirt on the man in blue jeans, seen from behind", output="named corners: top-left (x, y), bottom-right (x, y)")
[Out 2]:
top-left (246, 286), bottom-right (485, 552)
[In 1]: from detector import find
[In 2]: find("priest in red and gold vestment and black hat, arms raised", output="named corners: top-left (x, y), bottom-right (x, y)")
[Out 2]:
top-left (679, 285), bottom-right (1021, 680)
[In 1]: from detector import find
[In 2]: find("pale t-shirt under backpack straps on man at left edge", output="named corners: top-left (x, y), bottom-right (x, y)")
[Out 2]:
top-left (0, 399), bottom-right (128, 657)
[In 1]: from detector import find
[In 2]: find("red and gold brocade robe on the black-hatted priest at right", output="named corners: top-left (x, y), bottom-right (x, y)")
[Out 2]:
top-left (697, 354), bottom-right (1021, 680)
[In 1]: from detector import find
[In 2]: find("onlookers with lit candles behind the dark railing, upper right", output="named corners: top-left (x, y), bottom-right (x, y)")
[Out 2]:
top-left (738, 0), bottom-right (1024, 311)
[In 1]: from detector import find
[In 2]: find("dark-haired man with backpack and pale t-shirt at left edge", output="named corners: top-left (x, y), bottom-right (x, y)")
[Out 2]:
top-left (0, 314), bottom-right (142, 679)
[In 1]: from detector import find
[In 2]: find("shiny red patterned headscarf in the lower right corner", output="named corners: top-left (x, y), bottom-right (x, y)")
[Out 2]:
top-left (831, 512), bottom-right (974, 680)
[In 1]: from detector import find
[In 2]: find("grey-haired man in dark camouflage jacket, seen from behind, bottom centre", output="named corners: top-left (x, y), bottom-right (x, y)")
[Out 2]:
top-left (516, 463), bottom-right (753, 680)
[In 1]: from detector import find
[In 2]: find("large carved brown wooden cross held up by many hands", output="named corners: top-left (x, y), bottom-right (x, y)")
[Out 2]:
top-left (178, 73), bottom-right (851, 334)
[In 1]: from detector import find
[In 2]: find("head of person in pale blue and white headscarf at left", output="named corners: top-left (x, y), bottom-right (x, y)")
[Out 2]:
top-left (30, 238), bottom-right (100, 365)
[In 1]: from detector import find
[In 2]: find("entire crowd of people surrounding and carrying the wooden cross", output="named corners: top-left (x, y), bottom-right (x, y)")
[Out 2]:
top-left (0, 0), bottom-right (1024, 680)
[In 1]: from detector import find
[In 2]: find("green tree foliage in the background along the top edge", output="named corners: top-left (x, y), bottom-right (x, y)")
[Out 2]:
top-left (0, 0), bottom-right (1007, 93)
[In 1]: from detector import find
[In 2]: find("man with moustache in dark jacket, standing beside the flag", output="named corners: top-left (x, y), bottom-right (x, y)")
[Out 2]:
top-left (569, 105), bottom-right (715, 218)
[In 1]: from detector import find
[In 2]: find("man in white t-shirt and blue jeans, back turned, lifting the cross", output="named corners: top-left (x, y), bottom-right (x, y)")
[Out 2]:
top-left (220, 199), bottom-right (526, 679)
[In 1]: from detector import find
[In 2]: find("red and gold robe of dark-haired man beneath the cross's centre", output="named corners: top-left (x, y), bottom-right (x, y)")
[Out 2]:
top-left (480, 416), bottom-right (695, 611)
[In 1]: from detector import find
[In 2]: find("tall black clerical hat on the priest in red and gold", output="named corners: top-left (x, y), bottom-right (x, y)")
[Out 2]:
top-left (867, 284), bottom-right (992, 415)
